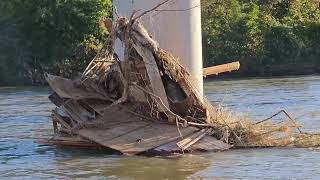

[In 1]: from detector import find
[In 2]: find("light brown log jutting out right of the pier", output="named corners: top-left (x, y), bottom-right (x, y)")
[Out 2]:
top-left (203, 61), bottom-right (240, 77)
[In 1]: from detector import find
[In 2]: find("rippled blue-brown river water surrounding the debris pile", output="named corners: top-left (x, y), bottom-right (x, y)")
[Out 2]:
top-left (0, 76), bottom-right (320, 180)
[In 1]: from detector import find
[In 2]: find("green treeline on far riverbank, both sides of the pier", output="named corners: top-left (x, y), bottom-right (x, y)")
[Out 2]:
top-left (0, 0), bottom-right (320, 85)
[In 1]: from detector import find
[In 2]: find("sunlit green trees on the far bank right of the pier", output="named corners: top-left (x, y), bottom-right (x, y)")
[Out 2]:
top-left (202, 0), bottom-right (320, 76)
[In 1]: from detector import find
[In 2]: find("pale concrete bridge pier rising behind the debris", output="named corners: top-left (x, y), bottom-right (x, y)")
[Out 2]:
top-left (113, 0), bottom-right (203, 94)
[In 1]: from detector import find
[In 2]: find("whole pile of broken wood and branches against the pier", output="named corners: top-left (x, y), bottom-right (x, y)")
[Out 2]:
top-left (42, 16), bottom-right (320, 154)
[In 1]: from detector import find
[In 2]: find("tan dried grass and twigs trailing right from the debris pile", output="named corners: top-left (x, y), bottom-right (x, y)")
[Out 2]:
top-left (209, 106), bottom-right (320, 148)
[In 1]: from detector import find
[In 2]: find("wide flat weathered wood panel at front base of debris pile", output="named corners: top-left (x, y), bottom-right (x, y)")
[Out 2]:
top-left (79, 121), bottom-right (197, 154)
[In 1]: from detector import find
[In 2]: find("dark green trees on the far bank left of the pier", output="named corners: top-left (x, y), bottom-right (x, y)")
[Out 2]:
top-left (0, 0), bottom-right (112, 83)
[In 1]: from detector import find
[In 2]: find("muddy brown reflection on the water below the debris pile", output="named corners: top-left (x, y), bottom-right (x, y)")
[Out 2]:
top-left (105, 155), bottom-right (208, 179)
